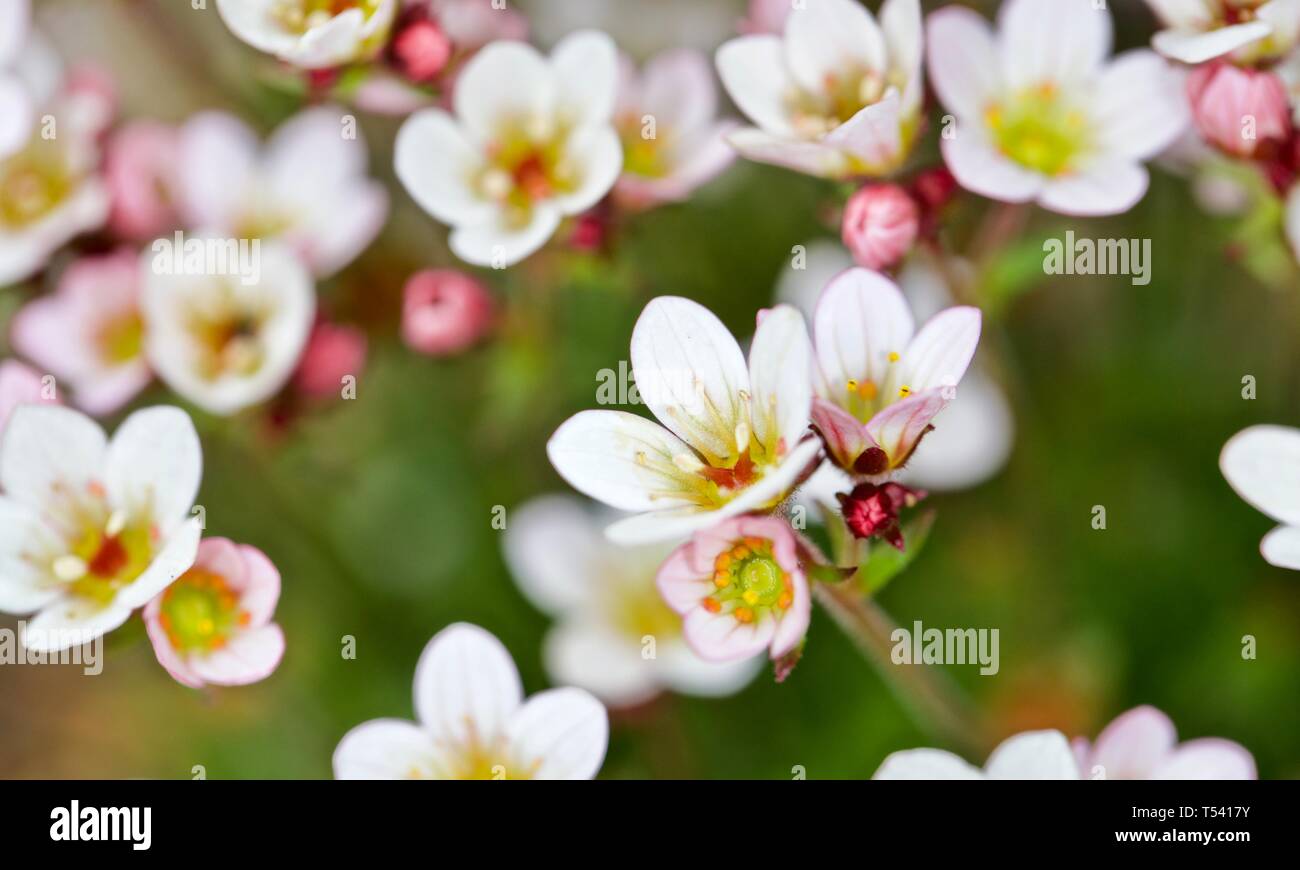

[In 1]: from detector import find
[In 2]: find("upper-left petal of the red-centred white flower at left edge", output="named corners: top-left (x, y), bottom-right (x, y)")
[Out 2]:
top-left (0, 404), bottom-right (108, 511)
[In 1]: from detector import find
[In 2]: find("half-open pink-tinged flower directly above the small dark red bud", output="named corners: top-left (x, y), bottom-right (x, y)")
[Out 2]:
top-left (813, 269), bottom-right (982, 482)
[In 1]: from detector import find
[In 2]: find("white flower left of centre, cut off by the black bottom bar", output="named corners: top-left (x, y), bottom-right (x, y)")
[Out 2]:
top-left (334, 623), bottom-right (610, 779)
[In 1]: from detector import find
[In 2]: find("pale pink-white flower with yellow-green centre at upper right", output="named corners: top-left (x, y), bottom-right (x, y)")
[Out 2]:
top-left (927, 0), bottom-right (1187, 215)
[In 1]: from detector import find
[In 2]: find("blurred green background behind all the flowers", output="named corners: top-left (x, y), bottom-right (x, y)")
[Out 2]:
top-left (0, 0), bottom-right (1300, 779)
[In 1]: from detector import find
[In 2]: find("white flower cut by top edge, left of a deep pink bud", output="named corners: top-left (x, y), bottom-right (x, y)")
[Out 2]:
top-left (217, 0), bottom-right (402, 69)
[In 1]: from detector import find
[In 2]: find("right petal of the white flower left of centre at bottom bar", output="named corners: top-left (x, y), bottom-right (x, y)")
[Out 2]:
top-left (507, 688), bottom-right (610, 779)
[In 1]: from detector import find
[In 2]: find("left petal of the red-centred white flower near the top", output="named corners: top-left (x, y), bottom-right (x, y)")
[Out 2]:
top-left (393, 109), bottom-right (495, 225)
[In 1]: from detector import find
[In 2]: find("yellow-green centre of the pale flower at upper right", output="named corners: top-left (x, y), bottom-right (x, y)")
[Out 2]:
top-left (984, 82), bottom-right (1088, 176)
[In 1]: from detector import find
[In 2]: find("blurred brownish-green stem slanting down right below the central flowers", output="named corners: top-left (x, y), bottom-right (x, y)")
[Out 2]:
top-left (813, 581), bottom-right (991, 761)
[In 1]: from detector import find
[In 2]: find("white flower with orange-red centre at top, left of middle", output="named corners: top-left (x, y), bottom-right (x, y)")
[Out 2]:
top-left (395, 31), bottom-right (623, 267)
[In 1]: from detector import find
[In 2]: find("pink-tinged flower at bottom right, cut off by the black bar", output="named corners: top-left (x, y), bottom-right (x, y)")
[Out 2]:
top-left (1074, 706), bottom-right (1257, 779)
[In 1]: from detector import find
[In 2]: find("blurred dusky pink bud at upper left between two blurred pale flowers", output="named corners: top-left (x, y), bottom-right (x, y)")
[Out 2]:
top-left (104, 121), bottom-right (181, 241)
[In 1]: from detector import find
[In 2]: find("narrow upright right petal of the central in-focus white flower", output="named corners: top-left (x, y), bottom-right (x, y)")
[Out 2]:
top-left (749, 306), bottom-right (813, 450)
